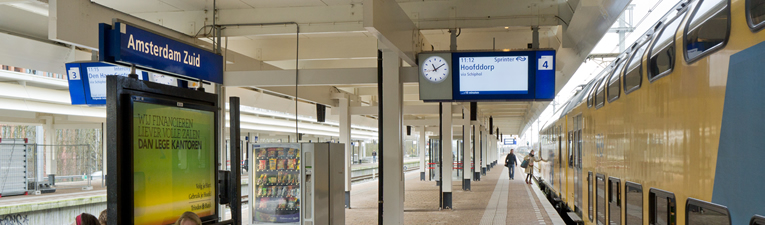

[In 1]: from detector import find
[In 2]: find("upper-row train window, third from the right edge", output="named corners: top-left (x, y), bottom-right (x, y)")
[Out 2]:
top-left (648, 11), bottom-right (687, 81)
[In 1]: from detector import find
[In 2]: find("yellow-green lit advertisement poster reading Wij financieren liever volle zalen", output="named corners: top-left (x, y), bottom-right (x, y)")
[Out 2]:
top-left (133, 102), bottom-right (215, 224)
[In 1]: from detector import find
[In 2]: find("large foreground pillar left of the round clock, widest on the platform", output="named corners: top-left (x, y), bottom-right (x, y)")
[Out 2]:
top-left (379, 50), bottom-right (404, 224)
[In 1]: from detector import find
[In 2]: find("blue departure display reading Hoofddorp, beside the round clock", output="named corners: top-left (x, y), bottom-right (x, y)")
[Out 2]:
top-left (452, 50), bottom-right (555, 101)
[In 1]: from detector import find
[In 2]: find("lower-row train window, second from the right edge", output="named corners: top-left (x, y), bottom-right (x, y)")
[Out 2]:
top-left (685, 198), bottom-right (731, 225)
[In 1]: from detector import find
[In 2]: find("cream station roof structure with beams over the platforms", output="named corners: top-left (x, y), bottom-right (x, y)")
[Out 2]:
top-left (0, 0), bottom-right (630, 137)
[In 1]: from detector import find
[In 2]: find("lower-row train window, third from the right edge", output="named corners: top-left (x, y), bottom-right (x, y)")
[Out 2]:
top-left (648, 188), bottom-right (677, 225)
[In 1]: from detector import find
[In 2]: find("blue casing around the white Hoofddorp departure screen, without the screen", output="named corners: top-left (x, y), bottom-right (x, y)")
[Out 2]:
top-left (452, 50), bottom-right (555, 101)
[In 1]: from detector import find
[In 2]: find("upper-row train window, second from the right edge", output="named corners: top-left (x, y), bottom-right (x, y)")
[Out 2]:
top-left (685, 0), bottom-right (730, 63)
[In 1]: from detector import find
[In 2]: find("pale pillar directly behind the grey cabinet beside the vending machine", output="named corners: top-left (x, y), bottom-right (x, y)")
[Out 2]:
top-left (338, 98), bottom-right (353, 209)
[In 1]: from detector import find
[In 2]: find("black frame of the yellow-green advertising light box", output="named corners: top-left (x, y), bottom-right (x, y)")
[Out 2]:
top-left (106, 76), bottom-right (218, 224)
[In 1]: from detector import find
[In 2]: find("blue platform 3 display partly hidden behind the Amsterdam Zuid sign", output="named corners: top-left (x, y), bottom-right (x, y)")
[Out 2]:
top-left (66, 62), bottom-right (149, 105)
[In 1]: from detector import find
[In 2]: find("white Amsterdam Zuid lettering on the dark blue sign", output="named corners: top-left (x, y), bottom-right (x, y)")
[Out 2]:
top-left (127, 34), bottom-right (202, 67)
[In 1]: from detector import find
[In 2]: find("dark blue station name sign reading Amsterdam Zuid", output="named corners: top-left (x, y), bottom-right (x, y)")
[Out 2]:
top-left (99, 22), bottom-right (223, 84)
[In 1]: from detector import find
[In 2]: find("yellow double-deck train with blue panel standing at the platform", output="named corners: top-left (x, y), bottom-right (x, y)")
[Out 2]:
top-left (535, 0), bottom-right (765, 225)
